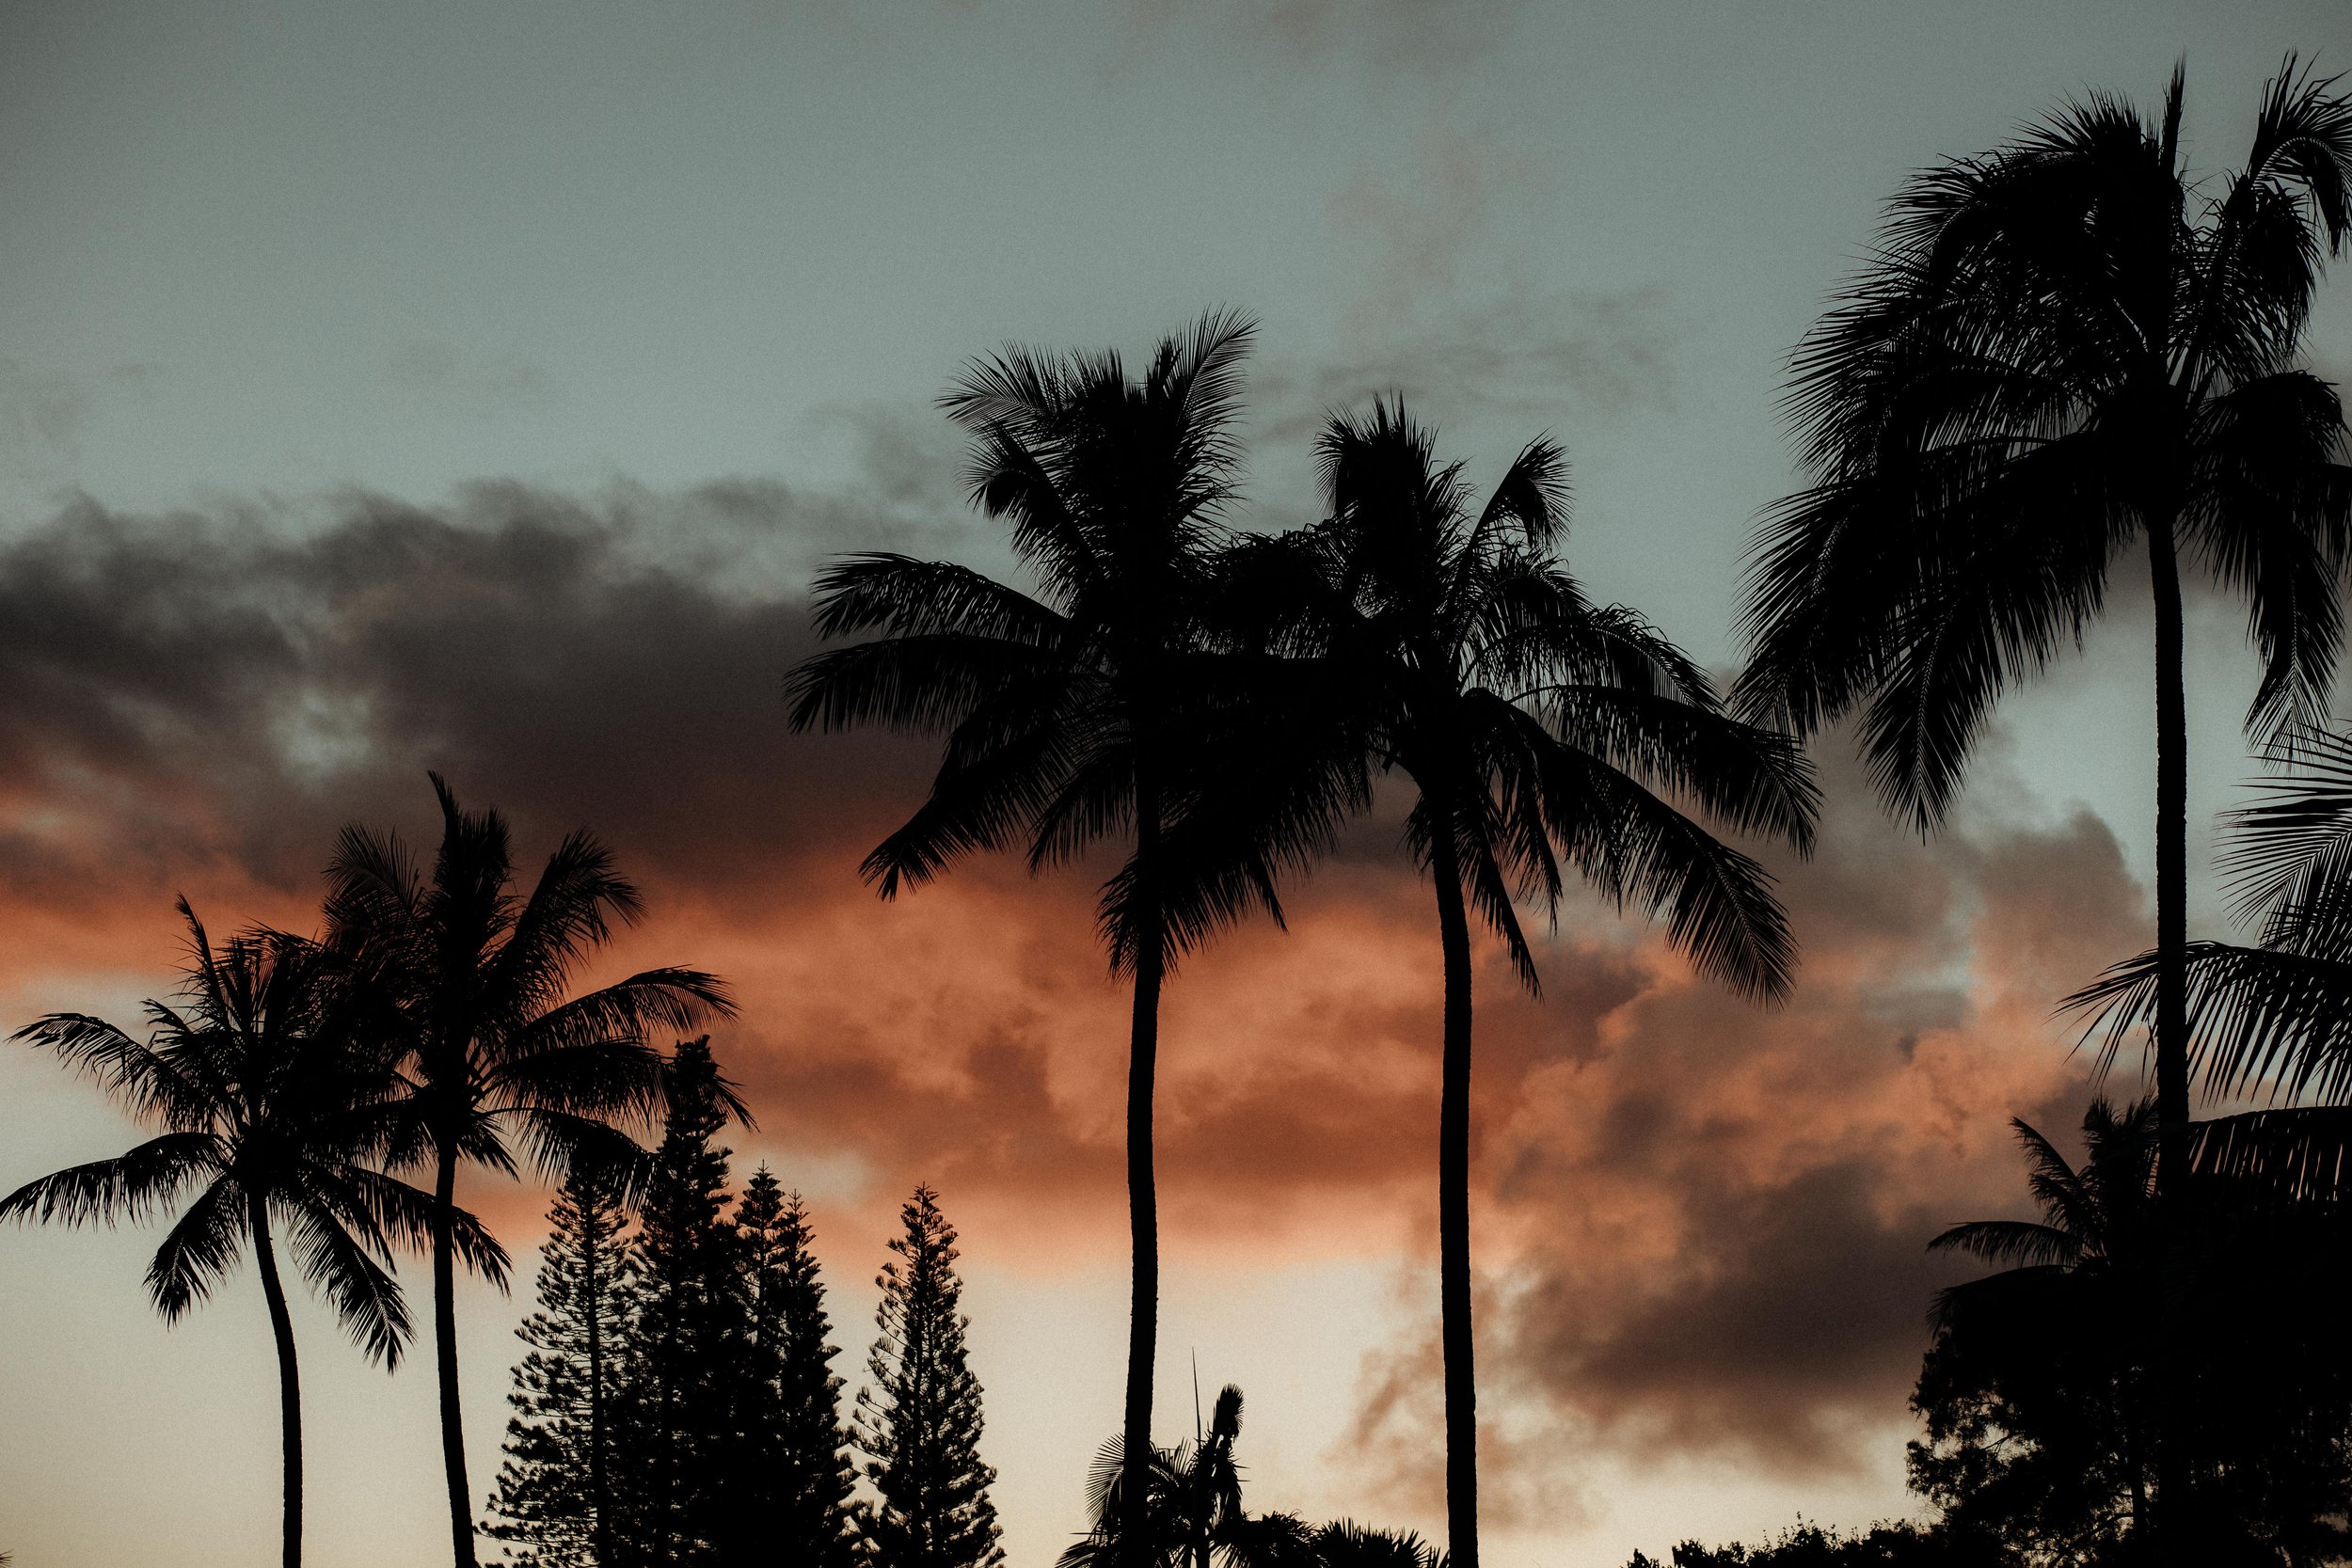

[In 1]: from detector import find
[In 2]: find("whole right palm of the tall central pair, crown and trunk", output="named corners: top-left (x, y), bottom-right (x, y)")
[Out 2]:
top-left (1228, 402), bottom-right (1816, 1568)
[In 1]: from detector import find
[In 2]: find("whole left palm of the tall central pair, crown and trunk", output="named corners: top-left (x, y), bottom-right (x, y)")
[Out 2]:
top-left (790, 315), bottom-right (1358, 1540)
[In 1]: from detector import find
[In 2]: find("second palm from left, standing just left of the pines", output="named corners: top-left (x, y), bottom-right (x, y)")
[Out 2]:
top-left (327, 773), bottom-right (734, 1568)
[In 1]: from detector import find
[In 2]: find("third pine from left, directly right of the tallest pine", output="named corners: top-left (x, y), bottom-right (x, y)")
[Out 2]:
top-left (737, 1166), bottom-right (854, 1568)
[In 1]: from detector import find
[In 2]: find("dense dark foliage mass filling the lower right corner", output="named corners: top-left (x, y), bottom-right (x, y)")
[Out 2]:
top-left (1910, 1101), bottom-right (2352, 1566)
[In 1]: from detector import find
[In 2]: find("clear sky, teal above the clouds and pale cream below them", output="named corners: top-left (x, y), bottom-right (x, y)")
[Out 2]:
top-left (0, 0), bottom-right (2352, 1568)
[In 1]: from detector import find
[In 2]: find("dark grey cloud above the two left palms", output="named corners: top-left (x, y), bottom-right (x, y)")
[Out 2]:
top-left (0, 480), bottom-right (983, 911)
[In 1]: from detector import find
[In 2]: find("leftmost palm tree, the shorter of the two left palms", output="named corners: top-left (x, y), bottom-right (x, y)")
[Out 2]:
top-left (0, 898), bottom-right (491, 1568)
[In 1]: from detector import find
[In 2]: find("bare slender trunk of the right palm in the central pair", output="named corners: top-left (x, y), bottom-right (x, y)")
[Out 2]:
top-left (1430, 820), bottom-right (1477, 1568)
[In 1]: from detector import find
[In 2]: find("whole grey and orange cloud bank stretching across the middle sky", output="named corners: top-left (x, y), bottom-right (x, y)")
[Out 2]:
top-left (0, 482), bottom-right (2145, 1516)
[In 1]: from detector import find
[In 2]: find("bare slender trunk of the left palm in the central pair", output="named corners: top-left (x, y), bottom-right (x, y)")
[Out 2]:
top-left (1120, 767), bottom-right (1165, 1563)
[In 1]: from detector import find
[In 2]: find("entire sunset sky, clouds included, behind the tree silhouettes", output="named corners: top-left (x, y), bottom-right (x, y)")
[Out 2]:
top-left (0, 0), bottom-right (2352, 1568)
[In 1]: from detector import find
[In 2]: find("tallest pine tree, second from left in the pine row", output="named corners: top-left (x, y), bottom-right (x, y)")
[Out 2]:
top-left (614, 1037), bottom-right (748, 1568)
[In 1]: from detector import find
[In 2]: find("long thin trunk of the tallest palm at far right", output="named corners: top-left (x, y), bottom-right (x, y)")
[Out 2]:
top-left (2148, 515), bottom-right (2190, 1568)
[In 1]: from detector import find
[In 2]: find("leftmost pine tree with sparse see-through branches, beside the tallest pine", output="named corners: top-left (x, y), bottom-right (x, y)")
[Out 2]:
top-left (485, 1173), bottom-right (628, 1568)
